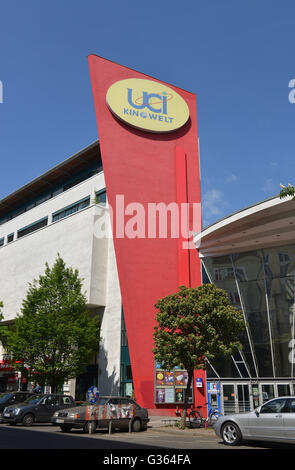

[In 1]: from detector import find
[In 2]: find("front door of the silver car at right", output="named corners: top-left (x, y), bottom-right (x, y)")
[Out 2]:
top-left (249, 398), bottom-right (288, 441)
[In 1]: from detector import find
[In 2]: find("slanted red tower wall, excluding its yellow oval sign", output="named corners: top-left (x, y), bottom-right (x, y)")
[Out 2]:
top-left (88, 55), bottom-right (201, 408)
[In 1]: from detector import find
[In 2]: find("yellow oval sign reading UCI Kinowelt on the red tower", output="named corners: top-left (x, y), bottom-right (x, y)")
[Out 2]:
top-left (106, 78), bottom-right (189, 132)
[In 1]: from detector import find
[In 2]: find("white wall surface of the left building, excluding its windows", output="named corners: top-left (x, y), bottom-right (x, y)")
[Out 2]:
top-left (0, 173), bottom-right (121, 394)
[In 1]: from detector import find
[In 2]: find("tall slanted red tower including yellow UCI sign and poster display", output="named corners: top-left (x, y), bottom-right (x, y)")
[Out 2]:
top-left (88, 55), bottom-right (205, 408)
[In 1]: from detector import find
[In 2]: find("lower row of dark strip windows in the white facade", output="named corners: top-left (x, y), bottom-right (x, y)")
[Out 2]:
top-left (0, 190), bottom-right (106, 247)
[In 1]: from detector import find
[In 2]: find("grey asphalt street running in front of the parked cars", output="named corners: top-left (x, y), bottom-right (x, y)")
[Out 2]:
top-left (0, 424), bottom-right (282, 451)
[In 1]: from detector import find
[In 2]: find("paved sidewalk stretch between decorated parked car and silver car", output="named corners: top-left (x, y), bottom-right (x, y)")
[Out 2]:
top-left (148, 416), bottom-right (215, 436)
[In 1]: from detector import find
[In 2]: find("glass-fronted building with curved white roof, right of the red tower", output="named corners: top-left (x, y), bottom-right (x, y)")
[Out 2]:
top-left (195, 197), bottom-right (295, 413)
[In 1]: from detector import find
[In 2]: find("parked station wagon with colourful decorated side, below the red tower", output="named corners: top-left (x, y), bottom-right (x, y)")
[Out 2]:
top-left (51, 396), bottom-right (149, 432)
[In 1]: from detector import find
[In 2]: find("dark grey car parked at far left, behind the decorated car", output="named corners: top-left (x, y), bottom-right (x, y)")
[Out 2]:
top-left (2, 393), bottom-right (76, 426)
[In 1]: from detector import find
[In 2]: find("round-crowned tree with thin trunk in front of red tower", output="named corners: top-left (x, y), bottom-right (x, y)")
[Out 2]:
top-left (153, 284), bottom-right (245, 428)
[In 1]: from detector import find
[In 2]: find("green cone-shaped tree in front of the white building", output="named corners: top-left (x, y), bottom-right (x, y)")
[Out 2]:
top-left (1, 255), bottom-right (99, 391)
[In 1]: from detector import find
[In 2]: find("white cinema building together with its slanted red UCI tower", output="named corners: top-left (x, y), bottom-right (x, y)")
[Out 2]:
top-left (0, 55), bottom-right (206, 414)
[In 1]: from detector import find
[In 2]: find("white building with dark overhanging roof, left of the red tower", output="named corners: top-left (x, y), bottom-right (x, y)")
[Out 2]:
top-left (0, 142), bottom-right (122, 399)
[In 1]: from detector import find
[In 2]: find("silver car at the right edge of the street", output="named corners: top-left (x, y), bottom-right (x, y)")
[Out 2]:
top-left (214, 397), bottom-right (295, 446)
